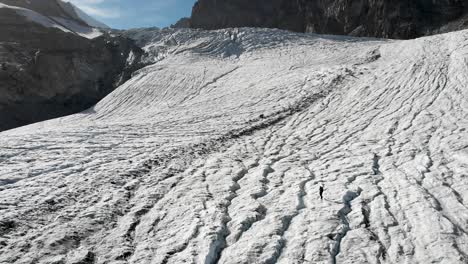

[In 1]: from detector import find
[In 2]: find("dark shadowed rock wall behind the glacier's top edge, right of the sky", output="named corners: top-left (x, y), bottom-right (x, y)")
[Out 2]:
top-left (190, 0), bottom-right (468, 39)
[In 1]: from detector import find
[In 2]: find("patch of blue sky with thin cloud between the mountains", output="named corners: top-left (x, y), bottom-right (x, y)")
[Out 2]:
top-left (68, 0), bottom-right (196, 29)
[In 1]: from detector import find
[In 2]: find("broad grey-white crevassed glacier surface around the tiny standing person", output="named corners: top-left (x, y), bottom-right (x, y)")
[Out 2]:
top-left (0, 29), bottom-right (468, 263)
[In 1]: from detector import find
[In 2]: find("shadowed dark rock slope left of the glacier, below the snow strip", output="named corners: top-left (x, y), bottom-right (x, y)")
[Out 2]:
top-left (0, 8), bottom-right (143, 131)
